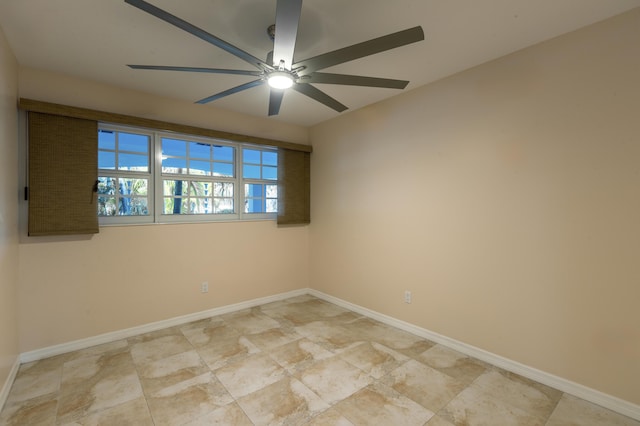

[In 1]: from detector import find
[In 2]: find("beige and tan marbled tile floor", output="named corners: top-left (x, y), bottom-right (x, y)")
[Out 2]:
top-left (0, 296), bottom-right (640, 426)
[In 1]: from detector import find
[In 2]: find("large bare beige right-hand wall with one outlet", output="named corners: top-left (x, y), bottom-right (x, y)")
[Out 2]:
top-left (310, 9), bottom-right (640, 404)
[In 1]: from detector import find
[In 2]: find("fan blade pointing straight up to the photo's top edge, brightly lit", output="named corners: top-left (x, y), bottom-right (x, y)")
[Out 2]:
top-left (269, 0), bottom-right (302, 70)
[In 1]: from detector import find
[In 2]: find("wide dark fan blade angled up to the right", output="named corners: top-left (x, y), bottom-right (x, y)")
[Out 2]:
top-left (293, 26), bottom-right (424, 76)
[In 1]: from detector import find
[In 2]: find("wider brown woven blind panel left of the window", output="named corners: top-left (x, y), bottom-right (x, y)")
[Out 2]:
top-left (29, 112), bottom-right (98, 236)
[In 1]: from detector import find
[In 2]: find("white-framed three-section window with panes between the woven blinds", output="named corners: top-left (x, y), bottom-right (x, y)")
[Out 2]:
top-left (98, 125), bottom-right (278, 224)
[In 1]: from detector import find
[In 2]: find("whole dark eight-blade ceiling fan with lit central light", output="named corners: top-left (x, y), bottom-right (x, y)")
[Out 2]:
top-left (125, 0), bottom-right (424, 116)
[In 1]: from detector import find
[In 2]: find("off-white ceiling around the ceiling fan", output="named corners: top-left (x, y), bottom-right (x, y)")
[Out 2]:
top-left (0, 0), bottom-right (640, 126)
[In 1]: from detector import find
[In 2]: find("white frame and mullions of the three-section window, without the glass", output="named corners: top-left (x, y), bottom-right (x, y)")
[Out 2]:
top-left (96, 123), bottom-right (281, 226)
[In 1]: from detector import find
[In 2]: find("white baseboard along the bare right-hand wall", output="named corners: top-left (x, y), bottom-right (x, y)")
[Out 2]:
top-left (308, 289), bottom-right (640, 420)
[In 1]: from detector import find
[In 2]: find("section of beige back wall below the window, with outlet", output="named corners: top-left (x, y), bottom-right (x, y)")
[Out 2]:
top-left (20, 221), bottom-right (308, 351)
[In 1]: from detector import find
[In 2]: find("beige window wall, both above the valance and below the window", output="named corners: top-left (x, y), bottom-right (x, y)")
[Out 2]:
top-left (14, 69), bottom-right (308, 352)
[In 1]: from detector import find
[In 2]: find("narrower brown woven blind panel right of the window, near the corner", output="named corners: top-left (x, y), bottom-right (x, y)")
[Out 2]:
top-left (278, 149), bottom-right (311, 225)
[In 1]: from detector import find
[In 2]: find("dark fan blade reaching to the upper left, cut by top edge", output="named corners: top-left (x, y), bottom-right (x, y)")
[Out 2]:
top-left (124, 0), bottom-right (273, 69)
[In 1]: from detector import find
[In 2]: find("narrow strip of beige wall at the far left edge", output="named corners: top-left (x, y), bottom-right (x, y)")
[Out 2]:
top-left (0, 28), bottom-right (19, 389)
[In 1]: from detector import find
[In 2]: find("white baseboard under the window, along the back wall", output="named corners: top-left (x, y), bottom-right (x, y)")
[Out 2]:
top-left (20, 288), bottom-right (309, 363)
